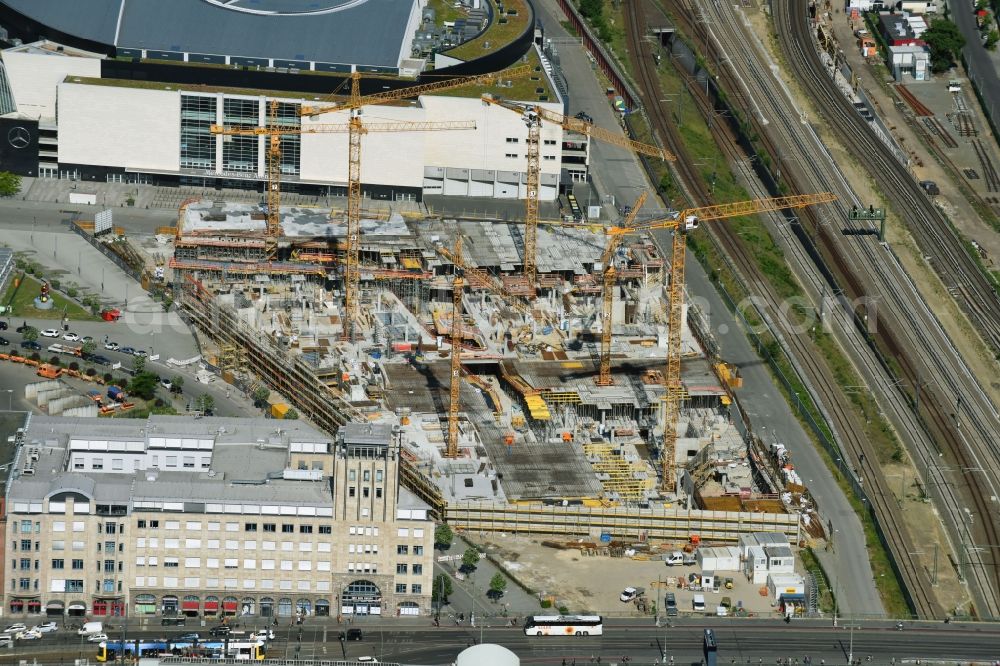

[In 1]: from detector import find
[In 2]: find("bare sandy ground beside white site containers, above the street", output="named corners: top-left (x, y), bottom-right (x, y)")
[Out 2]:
top-left (476, 534), bottom-right (777, 615)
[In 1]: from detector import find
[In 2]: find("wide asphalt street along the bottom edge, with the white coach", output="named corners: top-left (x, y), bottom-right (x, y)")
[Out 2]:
top-left (0, 618), bottom-right (1000, 666)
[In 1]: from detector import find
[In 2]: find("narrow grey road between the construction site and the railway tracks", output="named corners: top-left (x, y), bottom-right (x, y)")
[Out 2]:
top-left (536, 0), bottom-right (883, 615)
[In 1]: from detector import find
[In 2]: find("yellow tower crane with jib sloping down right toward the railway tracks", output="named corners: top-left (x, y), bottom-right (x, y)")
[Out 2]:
top-left (482, 95), bottom-right (676, 293)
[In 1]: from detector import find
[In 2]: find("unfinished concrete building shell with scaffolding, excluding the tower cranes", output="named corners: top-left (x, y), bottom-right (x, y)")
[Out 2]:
top-left (170, 195), bottom-right (770, 505)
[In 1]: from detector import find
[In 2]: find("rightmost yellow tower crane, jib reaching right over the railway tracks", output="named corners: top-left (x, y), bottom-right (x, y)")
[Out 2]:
top-left (601, 192), bottom-right (837, 492)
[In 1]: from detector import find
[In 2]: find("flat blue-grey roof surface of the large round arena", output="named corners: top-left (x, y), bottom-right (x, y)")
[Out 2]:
top-left (0, 0), bottom-right (419, 67)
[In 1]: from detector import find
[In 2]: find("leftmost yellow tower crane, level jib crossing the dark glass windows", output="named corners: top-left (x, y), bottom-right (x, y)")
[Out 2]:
top-left (209, 104), bottom-right (476, 259)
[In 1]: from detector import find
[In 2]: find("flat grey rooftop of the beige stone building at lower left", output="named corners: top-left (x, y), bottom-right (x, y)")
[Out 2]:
top-left (8, 416), bottom-right (332, 508)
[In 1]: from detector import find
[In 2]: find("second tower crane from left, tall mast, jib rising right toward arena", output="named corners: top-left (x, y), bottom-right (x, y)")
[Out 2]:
top-left (299, 65), bottom-right (535, 338)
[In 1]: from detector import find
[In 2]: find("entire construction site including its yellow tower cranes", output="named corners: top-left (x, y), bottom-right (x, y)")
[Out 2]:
top-left (169, 67), bottom-right (830, 539)
